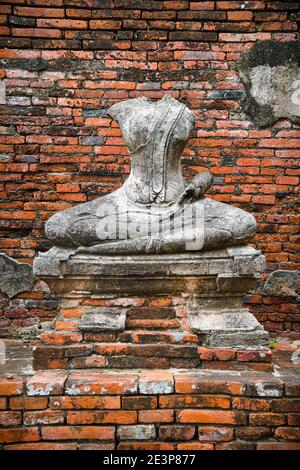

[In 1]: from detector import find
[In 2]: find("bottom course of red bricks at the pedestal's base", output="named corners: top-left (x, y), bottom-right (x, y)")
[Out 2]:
top-left (33, 342), bottom-right (273, 371)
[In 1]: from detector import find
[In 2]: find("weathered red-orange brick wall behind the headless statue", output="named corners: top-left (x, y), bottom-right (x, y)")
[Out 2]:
top-left (0, 0), bottom-right (300, 336)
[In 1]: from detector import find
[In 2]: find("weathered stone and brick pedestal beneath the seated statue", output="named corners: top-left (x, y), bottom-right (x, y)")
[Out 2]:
top-left (34, 245), bottom-right (270, 370)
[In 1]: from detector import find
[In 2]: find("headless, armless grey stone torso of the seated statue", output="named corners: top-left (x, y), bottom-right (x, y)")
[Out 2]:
top-left (108, 95), bottom-right (194, 204)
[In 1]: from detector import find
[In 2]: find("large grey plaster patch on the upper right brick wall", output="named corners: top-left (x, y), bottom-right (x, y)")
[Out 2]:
top-left (238, 41), bottom-right (300, 127)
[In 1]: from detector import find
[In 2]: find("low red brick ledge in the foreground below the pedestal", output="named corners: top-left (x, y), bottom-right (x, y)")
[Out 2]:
top-left (0, 371), bottom-right (300, 450)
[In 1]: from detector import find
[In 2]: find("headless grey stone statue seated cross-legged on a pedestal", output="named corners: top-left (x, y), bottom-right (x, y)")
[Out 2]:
top-left (46, 95), bottom-right (256, 254)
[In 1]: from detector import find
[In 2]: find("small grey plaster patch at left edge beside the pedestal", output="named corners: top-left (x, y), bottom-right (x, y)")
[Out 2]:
top-left (0, 253), bottom-right (34, 298)
